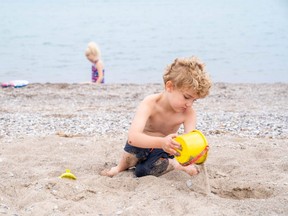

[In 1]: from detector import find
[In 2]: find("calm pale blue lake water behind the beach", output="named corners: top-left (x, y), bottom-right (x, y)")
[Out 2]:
top-left (0, 0), bottom-right (288, 83)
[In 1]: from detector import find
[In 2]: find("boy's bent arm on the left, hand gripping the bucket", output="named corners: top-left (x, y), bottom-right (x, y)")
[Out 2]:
top-left (128, 98), bottom-right (180, 155)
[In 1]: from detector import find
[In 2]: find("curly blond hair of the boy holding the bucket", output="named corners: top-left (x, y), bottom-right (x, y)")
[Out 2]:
top-left (163, 57), bottom-right (212, 98)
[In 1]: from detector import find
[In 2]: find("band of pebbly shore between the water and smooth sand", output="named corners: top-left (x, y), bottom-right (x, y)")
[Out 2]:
top-left (0, 84), bottom-right (288, 141)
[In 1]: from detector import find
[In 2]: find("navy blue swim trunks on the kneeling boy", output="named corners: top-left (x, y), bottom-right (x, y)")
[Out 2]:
top-left (124, 142), bottom-right (174, 177)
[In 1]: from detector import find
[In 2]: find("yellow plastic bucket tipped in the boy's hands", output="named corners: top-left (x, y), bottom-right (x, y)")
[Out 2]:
top-left (174, 130), bottom-right (209, 166)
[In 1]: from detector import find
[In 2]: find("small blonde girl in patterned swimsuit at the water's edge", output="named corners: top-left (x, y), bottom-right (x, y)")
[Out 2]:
top-left (85, 42), bottom-right (104, 84)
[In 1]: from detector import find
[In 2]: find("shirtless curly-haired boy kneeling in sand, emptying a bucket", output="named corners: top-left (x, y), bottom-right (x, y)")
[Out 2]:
top-left (101, 57), bottom-right (211, 177)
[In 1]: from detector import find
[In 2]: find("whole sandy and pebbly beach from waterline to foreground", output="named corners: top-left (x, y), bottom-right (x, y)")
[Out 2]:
top-left (0, 83), bottom-right (288, 216)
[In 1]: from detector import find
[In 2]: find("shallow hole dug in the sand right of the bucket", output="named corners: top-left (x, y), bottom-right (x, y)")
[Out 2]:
top-left (211, 182), bottom-right (273, 200)
